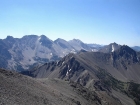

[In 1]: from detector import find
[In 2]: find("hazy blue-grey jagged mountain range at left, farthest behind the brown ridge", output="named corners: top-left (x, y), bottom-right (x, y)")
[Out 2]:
top-left (0, 35), bottom-right (100, 71)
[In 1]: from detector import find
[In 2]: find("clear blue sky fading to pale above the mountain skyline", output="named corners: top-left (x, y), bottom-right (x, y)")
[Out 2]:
top-left (0, 0), bottom-right (140, 46)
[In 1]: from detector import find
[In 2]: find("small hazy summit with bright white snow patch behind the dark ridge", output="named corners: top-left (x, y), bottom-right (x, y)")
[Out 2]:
top-left (99, 42), bottom-right (121, 53)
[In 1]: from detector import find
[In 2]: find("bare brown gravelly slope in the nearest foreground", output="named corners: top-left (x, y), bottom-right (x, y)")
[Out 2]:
top-left (0, 69), bottom-right (123, 105)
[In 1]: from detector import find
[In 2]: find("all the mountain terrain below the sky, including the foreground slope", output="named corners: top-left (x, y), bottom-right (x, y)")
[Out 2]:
top-left (0, 35), bottom-right (140, 105)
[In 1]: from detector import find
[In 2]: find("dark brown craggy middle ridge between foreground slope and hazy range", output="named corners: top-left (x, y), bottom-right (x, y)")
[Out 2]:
top-left (22, 44), bottom-right (140, 105)
